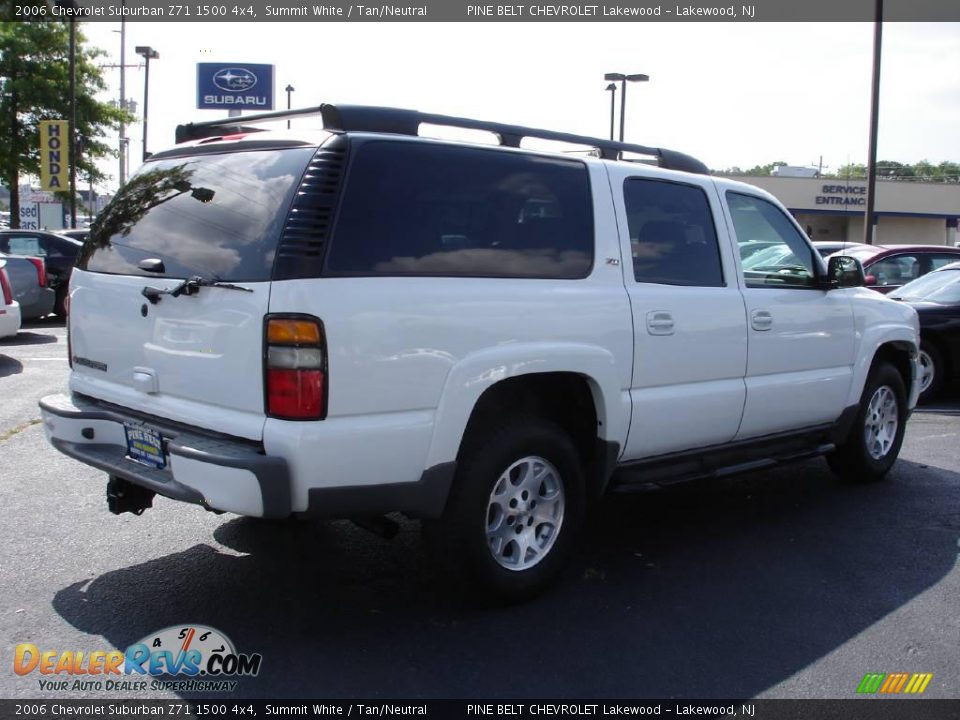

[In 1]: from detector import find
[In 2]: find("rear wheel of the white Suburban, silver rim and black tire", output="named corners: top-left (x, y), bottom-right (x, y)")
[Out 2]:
top-left (423, 415), bottom-right (585, 603)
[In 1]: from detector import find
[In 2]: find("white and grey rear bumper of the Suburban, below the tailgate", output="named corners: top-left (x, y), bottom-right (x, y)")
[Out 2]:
top-left (40, 395), bottom-right (290, 518)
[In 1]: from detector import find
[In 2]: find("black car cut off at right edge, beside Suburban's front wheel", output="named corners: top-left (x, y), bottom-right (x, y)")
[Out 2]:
top-left (890, 262), bottom-right (960, 400)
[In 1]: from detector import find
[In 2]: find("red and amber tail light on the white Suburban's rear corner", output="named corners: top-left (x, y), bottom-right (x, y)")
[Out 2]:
top-left (264, 315), bottom-right (327, 420)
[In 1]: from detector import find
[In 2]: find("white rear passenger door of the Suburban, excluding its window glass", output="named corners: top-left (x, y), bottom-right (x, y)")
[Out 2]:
top-left (609, 165), bottom-right (747, 460)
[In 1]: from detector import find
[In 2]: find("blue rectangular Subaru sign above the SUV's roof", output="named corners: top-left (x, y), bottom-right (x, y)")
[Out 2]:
top-left (197, 63), bottom-right (273, 110)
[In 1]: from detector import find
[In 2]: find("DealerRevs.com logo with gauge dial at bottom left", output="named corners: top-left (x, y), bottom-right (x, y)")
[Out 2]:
top-left (13, 625), bottom-right (263, 692)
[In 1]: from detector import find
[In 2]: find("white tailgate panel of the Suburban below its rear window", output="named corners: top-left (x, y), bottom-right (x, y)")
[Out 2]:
top-left (70, 269), bottom-right (270, 440)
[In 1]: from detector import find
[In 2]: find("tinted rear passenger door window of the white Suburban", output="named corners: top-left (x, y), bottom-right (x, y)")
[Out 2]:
top-left (623, 178), bottom-right (724, 287)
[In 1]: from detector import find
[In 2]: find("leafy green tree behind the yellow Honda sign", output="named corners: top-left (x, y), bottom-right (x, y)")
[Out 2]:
top-left (0, 13), bottom-right (132, 227)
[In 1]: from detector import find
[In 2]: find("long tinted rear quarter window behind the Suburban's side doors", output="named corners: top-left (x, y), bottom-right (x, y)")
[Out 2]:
top-left (327, 142), bottom-right (593, 279)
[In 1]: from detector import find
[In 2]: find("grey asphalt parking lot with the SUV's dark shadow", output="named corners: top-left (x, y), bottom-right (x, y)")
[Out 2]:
top-left (0, 323), bottom-right (960, 699)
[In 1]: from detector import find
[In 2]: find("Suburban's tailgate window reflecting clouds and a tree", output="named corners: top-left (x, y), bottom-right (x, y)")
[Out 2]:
top-left (77, 148), bottom-right (315, 282)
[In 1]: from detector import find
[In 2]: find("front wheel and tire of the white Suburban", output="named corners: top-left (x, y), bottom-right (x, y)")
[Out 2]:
top-left (827, 363), bottom-right (907, 483)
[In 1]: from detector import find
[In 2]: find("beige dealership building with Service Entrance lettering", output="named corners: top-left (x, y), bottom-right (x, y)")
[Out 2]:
top-left (736, 176), bottom-right (960, 245)
